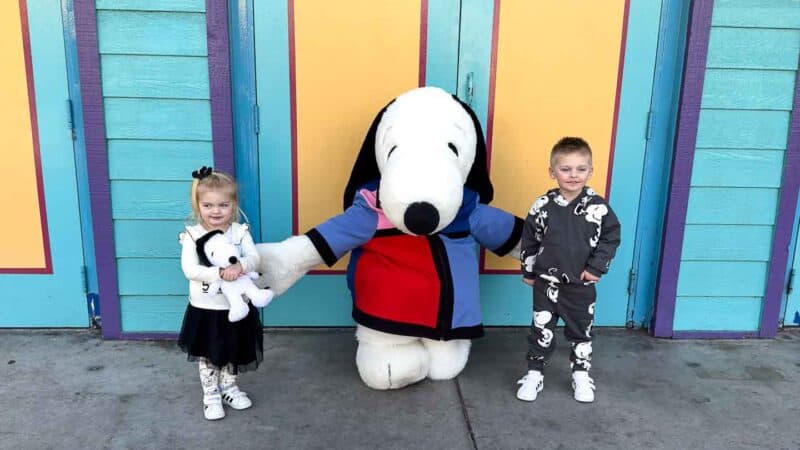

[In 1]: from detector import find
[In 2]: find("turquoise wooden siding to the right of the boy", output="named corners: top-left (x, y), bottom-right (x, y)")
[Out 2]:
top-left (666, 0), bottom-right (800, 331)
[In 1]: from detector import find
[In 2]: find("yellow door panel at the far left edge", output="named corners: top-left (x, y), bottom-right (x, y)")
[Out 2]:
top-left (0, 1), bottom-right (46, 269)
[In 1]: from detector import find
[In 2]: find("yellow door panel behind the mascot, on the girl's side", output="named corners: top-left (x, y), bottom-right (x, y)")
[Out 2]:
top-left (294, 0), bottom-right (421, 269)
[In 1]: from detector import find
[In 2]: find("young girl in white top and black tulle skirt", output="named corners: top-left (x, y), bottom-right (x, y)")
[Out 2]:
top-left (178, 167), bottom-right (263, 420)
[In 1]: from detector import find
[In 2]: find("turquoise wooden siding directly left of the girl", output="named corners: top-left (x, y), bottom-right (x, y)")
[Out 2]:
top-left (97, 0), bottom-right (213, 332)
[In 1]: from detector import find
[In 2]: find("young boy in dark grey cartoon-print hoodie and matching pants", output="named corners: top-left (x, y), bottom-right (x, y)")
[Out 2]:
top-left (517, 137), bottom-right (620, 403)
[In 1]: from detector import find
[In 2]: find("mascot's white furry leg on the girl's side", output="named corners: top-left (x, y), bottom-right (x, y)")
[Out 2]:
top-left (356, 325), bottom-right (428, 390)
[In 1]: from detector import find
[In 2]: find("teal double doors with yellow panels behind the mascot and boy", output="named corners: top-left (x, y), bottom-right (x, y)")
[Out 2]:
top-left (252, 0), bottom-right (661, 326)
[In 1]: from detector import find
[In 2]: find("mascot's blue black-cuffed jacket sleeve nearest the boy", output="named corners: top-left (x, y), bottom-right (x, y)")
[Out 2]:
top-left (469, 203), bottom-right (523, 256)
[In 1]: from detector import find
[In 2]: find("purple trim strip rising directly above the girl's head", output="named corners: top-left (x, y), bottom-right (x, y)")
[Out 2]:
top-left (206, 0), bottom-right (234, 174)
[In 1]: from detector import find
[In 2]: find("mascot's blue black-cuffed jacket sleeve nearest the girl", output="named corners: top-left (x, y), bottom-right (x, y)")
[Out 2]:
top-left (306, 194), bottom-right (378, 267)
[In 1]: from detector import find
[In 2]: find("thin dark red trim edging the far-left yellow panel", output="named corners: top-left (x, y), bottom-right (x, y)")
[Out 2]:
top-left (0, 0), bottom-right (53, 274)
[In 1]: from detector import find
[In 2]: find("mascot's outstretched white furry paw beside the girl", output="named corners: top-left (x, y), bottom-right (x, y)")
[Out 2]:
top-left (256, 236), bottom-right (322, 295)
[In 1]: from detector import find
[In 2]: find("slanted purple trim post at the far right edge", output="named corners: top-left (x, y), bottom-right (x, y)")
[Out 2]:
top-left (758, 71), bottom-right (800, 337)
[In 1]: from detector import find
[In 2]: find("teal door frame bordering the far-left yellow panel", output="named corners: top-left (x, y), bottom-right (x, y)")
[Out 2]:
top-left (0, 0), bottom-right (89, 327)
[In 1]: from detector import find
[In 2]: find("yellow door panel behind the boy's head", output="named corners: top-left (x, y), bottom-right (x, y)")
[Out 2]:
top-left (486, 0), bottom-right (625, 270)
